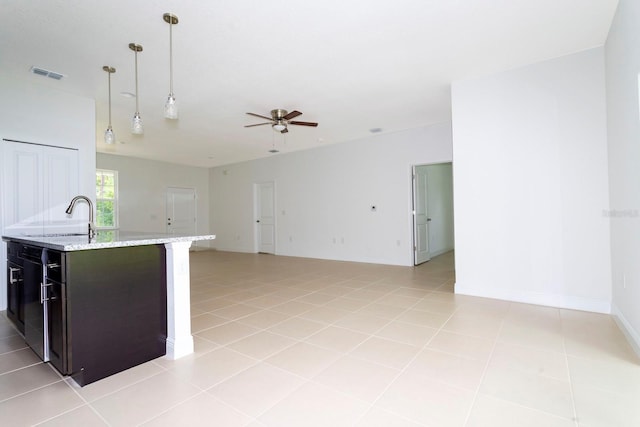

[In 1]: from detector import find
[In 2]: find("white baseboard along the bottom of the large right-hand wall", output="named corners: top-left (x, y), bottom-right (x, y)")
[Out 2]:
top-left (454, 282), bottom-right (611, 314)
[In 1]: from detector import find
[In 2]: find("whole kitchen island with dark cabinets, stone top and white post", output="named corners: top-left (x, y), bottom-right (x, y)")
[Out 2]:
top-left (2, 231), bottom-right (215, 385)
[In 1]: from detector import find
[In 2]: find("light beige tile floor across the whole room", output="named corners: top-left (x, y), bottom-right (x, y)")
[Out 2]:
top-left (0, 251), bottom-right (640, 427)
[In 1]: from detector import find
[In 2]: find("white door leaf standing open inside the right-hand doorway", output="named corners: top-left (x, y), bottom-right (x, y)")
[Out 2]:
top-left (413, 166), bottom-right (431, 265)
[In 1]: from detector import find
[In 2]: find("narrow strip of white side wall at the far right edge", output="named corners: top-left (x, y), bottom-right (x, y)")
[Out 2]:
top-left (606, 0), bottom-right (640, 354)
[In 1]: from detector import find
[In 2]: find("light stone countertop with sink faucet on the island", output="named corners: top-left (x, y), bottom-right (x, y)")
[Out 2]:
top-left (2, 230), bottom-right (216, 252)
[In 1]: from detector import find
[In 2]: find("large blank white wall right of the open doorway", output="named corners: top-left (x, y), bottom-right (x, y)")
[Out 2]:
top-left (452, 48), bottom-right (611, 313)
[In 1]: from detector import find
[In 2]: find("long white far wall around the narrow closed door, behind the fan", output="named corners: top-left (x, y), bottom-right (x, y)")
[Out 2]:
top-left (210, 123), bottom-right (451, 265)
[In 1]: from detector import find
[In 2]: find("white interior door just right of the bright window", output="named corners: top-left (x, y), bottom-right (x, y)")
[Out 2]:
top-left (167, 187), bottom-right (196, 236)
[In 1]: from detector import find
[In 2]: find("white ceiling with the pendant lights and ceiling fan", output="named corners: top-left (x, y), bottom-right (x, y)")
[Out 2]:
top-left (0, 0), bottom-right (617, 167)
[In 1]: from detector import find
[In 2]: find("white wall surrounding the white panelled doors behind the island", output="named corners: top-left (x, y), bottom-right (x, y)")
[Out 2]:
top-left (0, 77), bottom-right (96, 310)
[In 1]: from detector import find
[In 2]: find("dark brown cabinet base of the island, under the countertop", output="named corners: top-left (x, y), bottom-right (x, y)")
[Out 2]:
top-left (7, 242), bottom-right (167, 385)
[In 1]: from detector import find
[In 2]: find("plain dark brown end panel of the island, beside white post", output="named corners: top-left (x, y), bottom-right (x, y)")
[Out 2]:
top-left (63, 245), bottom-right (167, 385)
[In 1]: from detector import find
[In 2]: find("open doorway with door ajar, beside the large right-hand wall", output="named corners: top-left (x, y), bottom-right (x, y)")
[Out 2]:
top-left (412, 163), bottom-right (454, 265)
